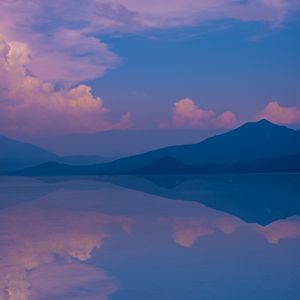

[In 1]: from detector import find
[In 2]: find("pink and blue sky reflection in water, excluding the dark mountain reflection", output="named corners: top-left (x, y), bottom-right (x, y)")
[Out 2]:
top-left (0, 176), bottom-right (300, 300)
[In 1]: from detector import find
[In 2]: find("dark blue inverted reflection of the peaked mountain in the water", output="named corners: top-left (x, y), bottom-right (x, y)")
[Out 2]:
top-left (102, 174), bottom-right (300, 225)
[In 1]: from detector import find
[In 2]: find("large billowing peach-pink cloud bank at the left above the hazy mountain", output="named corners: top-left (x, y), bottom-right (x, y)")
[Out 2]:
top-left (0, 36), bottom-right (133, 135)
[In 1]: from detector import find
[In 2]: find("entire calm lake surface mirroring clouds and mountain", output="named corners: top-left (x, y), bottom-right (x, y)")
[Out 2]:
top-left (0, 174), bottom-right (300, 300)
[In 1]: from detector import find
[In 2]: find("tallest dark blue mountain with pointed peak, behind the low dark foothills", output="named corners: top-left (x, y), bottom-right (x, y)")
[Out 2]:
top-left (100, 120), bottom-right (300, 172)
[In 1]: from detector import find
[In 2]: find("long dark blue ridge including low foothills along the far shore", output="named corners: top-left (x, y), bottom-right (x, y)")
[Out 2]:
top-left (15, 120), bottom-right (300, 175)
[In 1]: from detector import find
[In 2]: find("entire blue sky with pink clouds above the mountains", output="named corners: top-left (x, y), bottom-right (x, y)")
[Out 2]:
top-left (0, 0), bottom-right (300, 137)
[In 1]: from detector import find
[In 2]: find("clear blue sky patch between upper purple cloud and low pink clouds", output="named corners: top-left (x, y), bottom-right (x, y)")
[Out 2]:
top-left (89, 17), bottom-right (300, 122)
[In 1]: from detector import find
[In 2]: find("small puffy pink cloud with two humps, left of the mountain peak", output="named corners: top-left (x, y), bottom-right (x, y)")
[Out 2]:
top-left (162, 98), bottom-right (237, 128)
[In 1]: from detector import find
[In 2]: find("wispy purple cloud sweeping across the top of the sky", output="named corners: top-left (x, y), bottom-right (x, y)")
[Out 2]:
top-left (0, 0), bottom-right (299, 82)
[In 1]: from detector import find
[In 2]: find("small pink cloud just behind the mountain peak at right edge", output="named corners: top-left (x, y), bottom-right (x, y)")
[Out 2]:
top-left (255, 101), bottom-right (300, 124)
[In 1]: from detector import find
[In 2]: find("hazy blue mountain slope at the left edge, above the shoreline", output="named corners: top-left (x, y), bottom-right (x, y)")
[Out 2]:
top-left (0, 136), bottom-right (59, 172)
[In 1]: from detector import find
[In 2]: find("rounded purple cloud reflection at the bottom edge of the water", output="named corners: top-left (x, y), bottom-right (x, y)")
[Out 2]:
top-left (28, 262), bottom-right (118, 300)
